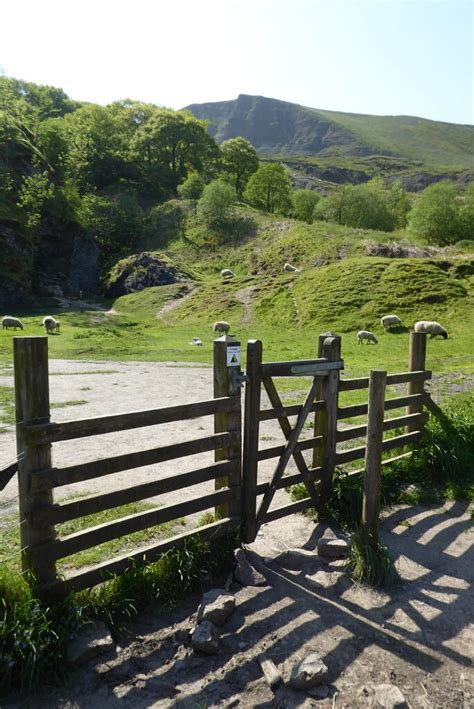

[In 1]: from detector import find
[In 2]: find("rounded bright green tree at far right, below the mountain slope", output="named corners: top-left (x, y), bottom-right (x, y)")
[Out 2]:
top-left (408, 180), bottom-right (462, 246)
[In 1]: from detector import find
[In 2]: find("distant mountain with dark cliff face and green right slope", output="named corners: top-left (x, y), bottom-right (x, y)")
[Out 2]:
top-left (187, 95), bottom-right (474, 180)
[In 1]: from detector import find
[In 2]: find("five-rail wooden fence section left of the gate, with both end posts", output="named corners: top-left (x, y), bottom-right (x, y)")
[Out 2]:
top-left (14, 337), bottom-right (241, 594)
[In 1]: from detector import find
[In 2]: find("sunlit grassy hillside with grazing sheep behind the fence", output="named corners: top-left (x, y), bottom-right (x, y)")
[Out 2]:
top-left (0, 210), bottom-right (474, 398)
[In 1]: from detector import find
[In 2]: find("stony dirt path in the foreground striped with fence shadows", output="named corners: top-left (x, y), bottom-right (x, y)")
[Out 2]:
top-left (4, 503), bottom-right (474, 709)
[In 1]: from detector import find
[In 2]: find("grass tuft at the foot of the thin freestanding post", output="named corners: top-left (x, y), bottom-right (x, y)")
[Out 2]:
top-left (347, 527), bottom-right (398, 588)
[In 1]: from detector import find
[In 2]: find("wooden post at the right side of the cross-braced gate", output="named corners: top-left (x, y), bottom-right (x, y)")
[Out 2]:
top-left (313, 335), bottom-right (341, 512)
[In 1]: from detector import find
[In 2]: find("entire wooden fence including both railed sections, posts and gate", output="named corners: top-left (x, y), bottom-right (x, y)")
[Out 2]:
top-left (9, 333), bottom-right (432, 594)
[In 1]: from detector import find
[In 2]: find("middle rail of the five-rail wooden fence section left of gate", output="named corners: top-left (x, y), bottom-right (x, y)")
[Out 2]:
top-left (35, 460), bottom-right (239, 524)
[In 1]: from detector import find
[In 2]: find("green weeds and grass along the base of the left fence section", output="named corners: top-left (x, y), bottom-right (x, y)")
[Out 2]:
top-left (0, 531), bottom-right (238, 690)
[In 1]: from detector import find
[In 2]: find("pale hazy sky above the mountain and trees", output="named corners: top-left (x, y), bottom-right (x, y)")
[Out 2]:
top-left (0, 0), bottom-right (474, 123)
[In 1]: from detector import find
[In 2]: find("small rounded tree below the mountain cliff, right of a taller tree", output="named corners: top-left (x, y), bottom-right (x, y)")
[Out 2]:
top-left (244, 163), bottom-right (291, 214)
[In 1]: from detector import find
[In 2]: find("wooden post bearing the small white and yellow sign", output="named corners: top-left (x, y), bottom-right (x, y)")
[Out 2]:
top-left (214, 335), bottom-right (242, 517)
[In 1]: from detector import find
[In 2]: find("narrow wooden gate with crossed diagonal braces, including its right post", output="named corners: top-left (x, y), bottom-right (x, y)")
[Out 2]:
top-left (242, 336), bottom-right (344, 542)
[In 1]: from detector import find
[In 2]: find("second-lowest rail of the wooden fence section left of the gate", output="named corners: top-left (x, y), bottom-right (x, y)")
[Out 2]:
top-left (32, 489), bottom-right (237, 564)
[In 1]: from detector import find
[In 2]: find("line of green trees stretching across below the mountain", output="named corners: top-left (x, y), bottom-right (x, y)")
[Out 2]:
top-left (0, 76), bottom-right (474, 280)
